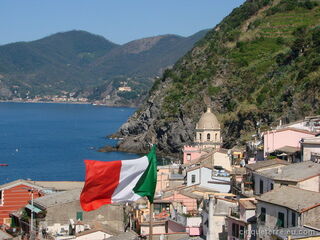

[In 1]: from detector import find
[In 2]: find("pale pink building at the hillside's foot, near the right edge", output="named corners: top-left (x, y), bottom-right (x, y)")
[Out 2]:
top-left (263, 128), bottom-right (316, 157)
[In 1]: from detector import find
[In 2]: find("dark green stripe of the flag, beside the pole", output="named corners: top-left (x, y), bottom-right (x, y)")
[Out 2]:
top-left (133, 145), bottom-right (157, 203)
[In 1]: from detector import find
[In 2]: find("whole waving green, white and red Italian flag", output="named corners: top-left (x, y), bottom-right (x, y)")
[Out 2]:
top-left (80, 145), bottom-right (157, 211)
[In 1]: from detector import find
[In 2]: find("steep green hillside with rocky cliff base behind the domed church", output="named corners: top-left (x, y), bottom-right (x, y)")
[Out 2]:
top-left (114, 0), bottom-right (320, 153)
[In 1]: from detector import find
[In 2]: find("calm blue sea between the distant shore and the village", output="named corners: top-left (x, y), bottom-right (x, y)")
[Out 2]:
top-left (0, 103), bottom-right (139, 184)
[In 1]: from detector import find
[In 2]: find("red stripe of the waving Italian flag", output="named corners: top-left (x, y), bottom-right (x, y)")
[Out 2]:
top-left (80, 160), bottom-right (122, 211)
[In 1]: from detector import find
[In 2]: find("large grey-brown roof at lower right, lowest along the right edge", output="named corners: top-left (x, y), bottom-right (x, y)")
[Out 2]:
top-left (257, 186), bottom-right (320, 213)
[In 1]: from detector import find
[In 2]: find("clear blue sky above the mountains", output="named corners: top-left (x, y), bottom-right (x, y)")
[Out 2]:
top-left (0, 0), bottom-right (244, 45)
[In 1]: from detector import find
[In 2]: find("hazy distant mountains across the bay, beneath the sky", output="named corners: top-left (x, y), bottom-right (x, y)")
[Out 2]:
top-left (0, 30), bottom-right (207, 105)
